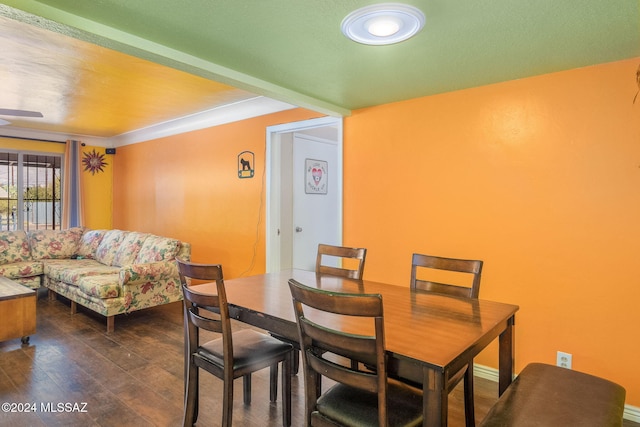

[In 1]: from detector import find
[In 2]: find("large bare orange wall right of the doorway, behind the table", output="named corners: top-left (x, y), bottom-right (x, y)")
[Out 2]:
top-left (344, 58), bottom-right (640, 406)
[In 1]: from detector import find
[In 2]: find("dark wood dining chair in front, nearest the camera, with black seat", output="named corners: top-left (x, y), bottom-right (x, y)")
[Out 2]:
top-left (289, 279), bottom-right (422, 427)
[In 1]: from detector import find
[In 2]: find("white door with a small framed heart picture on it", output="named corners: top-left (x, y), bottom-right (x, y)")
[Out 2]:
top-left (292, 134), bottom-right (341, 270)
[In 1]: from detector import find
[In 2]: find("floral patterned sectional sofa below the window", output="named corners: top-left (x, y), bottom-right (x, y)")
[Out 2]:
top-left (0, 228), bottom-right (191, 332)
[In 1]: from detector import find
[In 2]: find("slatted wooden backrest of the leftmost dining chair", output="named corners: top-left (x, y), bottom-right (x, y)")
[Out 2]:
top-left (176, 259), bottom-right (233, 366)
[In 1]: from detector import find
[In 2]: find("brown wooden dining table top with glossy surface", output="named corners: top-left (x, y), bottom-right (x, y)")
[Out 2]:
top-left (194, 270), bottom-right (519, 372)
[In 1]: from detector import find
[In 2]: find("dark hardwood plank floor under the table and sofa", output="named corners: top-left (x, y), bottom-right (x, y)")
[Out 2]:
top-left (0, 290), bottom-right (640, 427)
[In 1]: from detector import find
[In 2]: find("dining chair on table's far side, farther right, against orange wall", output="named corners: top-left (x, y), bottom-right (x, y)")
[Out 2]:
top-left (410, 254), bottom-right (483, 427)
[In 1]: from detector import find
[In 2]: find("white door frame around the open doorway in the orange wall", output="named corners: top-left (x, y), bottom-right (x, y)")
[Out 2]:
top-left (265, 116), bottom-right (343, 273)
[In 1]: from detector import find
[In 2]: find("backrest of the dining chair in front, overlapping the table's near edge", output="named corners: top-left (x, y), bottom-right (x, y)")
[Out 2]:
top-left (289, 279), bottom-right (387, 425)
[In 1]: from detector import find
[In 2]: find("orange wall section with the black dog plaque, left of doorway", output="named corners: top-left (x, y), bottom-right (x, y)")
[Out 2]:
top-left (113, 109), bottom-right (320, 278)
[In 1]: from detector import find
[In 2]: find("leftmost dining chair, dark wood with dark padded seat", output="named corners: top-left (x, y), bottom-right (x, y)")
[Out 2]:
top-left (177, 260), bottom-right (293, 427)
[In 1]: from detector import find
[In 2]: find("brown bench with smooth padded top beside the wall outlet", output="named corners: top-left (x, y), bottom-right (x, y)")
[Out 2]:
top-left (481, 363), bottom-right (625, 427)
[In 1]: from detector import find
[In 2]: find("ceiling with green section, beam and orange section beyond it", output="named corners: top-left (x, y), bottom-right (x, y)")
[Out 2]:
top-left (0, 0), bottom-right (640, 144)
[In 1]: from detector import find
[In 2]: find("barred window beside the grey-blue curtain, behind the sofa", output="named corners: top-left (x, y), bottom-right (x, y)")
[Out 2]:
top-left (0, 152), bottom-right (62, 231)
